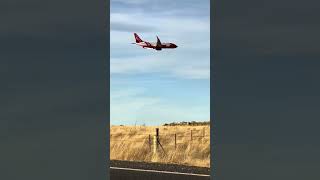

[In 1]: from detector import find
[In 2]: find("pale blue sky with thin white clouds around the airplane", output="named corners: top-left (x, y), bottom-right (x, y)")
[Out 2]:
top-left (110, 0), bottom-right (210, 125)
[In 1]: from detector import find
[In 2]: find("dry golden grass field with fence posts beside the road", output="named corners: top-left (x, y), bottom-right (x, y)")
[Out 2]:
top-left (110, 125), bottom-right (210, 167)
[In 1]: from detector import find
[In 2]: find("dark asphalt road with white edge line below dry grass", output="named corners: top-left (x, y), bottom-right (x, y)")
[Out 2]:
top-left (110, 161), bottom-right (210, 180)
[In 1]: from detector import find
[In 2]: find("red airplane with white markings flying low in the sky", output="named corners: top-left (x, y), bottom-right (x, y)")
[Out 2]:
top-left (132, 33), bottom-right (178, 51)
